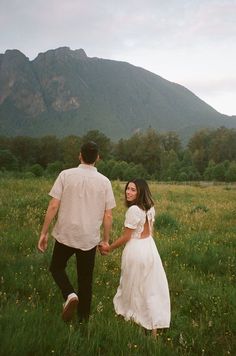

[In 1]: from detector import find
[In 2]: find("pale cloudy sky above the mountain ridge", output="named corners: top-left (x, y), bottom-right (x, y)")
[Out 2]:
top-left (0, 0), bottom-right (236, 115)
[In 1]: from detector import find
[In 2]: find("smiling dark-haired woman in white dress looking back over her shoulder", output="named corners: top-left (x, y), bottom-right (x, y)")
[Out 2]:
top-left (100, 179), bottom-right (170, 336)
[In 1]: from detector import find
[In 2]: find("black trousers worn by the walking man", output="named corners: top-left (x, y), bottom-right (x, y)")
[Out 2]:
top-left (50, 240), bottom-right (96, 320)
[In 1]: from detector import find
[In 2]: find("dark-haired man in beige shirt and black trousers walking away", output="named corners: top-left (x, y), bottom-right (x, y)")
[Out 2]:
top-left (38, 141), bottom-right (116, 321)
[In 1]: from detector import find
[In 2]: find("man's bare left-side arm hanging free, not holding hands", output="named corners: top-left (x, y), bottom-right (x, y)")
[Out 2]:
top-left (38, 198), bottom-right (60, 252)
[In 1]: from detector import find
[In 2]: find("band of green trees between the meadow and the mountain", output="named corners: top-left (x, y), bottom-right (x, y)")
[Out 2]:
top-left (0, 127), bottom-right (236, 182)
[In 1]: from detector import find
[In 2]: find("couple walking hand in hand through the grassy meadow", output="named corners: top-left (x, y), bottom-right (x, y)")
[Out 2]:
top-left (38, 141), bottom-right (170, 336)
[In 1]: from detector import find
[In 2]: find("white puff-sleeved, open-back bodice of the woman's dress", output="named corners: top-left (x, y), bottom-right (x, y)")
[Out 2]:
top-left (124, 205), bottom-right (155, 239)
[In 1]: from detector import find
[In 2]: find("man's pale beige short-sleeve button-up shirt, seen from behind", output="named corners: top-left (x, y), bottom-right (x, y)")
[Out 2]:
top-left (49, 164), bottom-right (116, 251)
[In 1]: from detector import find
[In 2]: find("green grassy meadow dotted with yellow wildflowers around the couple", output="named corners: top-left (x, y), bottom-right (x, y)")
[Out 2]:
top-left (0, 178), bottom-right (236, 356)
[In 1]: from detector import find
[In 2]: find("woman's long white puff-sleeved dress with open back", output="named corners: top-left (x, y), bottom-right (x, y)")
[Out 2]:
top-left (113, 205), bottom-right (170, 330)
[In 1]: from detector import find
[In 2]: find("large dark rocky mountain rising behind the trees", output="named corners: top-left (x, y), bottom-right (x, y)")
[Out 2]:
top-left (0, 47), bottom-right (236, 139)
